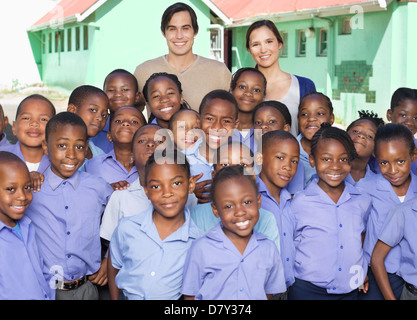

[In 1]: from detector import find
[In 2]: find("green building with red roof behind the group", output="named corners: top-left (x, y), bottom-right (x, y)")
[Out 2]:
top-left (28, 0), bottom-right (417, 124)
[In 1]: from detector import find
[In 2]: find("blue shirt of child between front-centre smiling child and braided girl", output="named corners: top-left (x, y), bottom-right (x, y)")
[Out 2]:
top-left (256, 176), bottom-right (295, 287)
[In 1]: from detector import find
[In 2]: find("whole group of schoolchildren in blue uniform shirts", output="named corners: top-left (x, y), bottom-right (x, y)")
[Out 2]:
top-left (0, 68), bottom-right (417, 300)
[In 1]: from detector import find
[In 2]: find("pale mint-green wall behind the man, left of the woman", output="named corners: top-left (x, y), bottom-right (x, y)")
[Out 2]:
top-left (34, 0), bottom-right (210, 91)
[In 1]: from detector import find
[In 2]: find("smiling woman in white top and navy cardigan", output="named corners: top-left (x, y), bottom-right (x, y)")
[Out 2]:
top-left (246, 20), bottom-right (316, 136)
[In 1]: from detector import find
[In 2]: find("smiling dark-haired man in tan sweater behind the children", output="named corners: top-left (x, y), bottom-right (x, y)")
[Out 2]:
top-left (134, 2), bottom-right (231, 114)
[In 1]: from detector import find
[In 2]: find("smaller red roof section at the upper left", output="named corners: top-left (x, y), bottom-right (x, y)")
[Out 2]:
top-left (29, 0), bottom-right (106, 31)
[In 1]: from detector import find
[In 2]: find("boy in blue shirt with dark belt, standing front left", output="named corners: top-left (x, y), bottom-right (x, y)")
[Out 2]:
top-left (27, 112), bottom-right (113, 300)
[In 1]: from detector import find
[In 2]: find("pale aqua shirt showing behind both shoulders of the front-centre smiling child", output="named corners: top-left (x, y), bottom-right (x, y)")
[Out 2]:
top-left (191, 202), bottom-right (280, 251)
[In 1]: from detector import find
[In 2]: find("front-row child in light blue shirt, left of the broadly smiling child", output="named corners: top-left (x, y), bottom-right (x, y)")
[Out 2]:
top-left (108, 150), bottom-right (202, 300)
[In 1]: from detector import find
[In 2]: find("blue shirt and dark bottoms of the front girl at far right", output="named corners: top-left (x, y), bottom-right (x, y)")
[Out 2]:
top-left (361, 174), bottom-right (417, 300)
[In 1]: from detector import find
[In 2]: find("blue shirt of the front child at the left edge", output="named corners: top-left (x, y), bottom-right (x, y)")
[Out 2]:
top-left (0, 216), bottom-right (54, 300)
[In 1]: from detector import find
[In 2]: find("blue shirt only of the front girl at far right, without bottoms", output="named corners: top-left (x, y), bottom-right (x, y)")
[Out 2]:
top-left (363, 174), bottom-right (417, 273)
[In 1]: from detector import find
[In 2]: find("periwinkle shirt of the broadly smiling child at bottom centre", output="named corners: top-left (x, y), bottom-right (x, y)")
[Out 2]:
top-left (181, 223), bottom-right (286, 300)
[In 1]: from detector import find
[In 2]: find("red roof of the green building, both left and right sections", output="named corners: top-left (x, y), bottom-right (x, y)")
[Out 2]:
top-left (29, 0), bottom-right (410, 31)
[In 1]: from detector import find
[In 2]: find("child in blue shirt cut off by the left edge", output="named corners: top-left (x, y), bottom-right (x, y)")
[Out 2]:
top-left (0, 151), bottom-right (51, 300)
